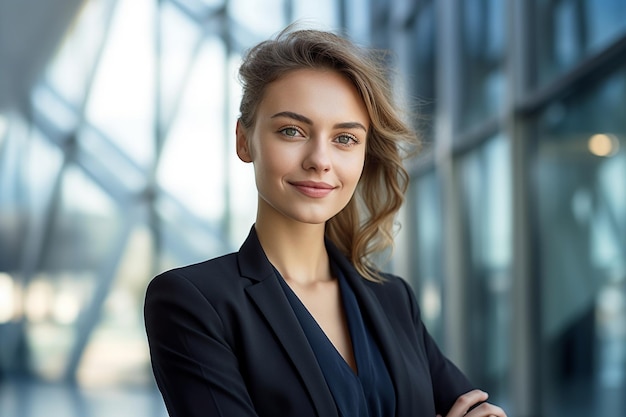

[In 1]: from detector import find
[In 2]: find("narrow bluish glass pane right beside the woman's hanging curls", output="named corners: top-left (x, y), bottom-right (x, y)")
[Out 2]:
top-left (411, 171), bottom-right (445, 348)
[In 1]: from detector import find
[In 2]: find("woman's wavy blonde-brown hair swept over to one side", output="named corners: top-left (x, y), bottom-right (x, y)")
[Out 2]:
top-left (239, 26), bottom-right (419, 282)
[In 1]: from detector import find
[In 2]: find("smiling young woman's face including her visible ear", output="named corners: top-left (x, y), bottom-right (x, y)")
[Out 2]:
top-left (237, 69), bottom-right (369, 224)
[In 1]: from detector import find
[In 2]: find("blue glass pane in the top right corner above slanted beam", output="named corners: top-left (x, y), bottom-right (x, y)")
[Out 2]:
top-left (533, 0), bottom-right (626, 84)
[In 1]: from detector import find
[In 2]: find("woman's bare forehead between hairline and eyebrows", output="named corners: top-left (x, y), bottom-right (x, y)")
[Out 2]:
top-left (257, 69), bottom-right (369, 126)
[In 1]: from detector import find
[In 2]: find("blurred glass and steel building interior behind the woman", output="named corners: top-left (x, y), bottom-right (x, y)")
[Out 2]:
top-left (0, 0), bottom-right (626, 417)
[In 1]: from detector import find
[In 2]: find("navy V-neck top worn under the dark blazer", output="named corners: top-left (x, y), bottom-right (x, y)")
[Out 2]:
top-left (276, 268), bottom-right (396, 417)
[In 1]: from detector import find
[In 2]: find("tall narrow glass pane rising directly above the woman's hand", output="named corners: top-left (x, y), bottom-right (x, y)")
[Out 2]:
top-left (459, 136), bottom-right (513, 407)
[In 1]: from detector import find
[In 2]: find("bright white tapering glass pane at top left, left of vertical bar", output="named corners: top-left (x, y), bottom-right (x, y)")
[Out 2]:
top-left (87, 0), bottom-right (156, 167)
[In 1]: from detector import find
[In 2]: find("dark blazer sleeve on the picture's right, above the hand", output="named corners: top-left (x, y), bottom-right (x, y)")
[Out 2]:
top-left (400, 280), bottom-right (476, 416)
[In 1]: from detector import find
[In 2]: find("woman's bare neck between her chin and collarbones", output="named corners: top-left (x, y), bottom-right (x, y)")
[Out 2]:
top-left (254, 205), bottom-right (331, 285)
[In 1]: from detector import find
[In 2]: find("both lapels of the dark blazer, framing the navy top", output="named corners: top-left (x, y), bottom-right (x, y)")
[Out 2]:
top-left (238, 226), bottom-right (418, 417)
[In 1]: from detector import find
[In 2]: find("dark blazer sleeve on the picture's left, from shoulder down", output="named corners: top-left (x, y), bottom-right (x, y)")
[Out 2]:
top-left (144, 271), bottom-right (257, 417)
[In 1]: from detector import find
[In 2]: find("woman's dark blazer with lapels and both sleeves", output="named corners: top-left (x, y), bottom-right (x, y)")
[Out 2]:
top-left (145, 227), bottom-right (474, 417)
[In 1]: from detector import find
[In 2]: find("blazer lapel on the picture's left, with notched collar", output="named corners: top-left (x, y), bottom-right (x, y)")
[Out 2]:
top-left (238, 227), bottom-right (338, 417)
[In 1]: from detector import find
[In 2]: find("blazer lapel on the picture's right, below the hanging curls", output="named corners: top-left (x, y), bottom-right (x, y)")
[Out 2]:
top-left (326, 242), bottom-right (419, 416)
